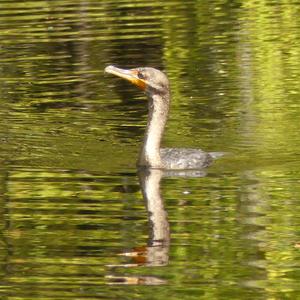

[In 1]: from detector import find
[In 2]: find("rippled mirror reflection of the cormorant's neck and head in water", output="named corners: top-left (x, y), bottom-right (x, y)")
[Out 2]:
top-left (106, 169), bottom-right (170, 285)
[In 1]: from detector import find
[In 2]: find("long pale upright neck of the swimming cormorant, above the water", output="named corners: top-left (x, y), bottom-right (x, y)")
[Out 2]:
top-left (138, 94), bottom-right (169, 168)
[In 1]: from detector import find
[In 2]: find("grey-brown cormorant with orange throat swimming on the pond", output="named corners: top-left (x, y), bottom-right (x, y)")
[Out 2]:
top-left (105, 65), bottom-right (215, 170)
